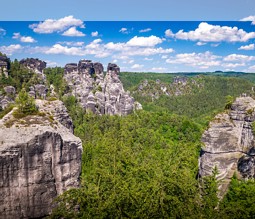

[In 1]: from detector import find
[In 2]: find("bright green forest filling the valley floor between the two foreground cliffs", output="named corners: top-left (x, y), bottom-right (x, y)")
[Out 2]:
top-left (50, 112), bottom-right (206, 218)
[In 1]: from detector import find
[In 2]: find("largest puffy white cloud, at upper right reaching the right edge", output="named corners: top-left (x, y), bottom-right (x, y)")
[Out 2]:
top-left (166, 22), bottom-right (255, 42)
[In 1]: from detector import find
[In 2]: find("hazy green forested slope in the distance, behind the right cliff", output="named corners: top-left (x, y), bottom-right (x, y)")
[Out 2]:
top-left (134, 76), bottom-right (253, 126)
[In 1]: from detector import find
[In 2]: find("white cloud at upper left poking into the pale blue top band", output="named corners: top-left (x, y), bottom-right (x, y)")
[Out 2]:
top-left (29, 15), bottom-right (85, 33)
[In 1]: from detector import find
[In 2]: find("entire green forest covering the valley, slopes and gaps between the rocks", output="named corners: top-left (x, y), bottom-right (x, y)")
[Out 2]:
top-left (0, 64), bottom-right (255, 219)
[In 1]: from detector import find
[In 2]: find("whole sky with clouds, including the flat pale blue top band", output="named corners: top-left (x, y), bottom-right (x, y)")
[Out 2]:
top-left (0, 0), bottom-right (255, 73)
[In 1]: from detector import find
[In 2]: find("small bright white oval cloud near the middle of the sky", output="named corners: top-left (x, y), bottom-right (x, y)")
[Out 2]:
top-left (127, 35), bottom-right (163, 47)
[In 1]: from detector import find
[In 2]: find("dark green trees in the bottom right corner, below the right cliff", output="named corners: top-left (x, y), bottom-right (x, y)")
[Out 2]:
top-left (219, 176), bottom-right (255, 219)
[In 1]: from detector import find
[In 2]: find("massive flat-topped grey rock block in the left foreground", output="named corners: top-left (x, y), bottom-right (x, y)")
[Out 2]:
top-left (0, 100), bottom-right (82, 219)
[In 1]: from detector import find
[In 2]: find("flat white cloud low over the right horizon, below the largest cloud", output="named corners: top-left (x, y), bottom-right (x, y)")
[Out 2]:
top-left (166, 51), bottom-right (221, 69)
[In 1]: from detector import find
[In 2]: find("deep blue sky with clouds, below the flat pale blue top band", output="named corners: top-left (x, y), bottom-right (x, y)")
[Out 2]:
top-left (0, 18), bottom-right (255, 72)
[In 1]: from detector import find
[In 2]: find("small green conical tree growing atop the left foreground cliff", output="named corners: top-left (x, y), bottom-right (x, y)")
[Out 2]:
top-left (13, 88), bottom-right (38, 118)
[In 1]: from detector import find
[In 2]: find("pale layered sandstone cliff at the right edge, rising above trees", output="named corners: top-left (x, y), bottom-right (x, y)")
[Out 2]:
top-left (199, 97), bottom-right (255, 196)
